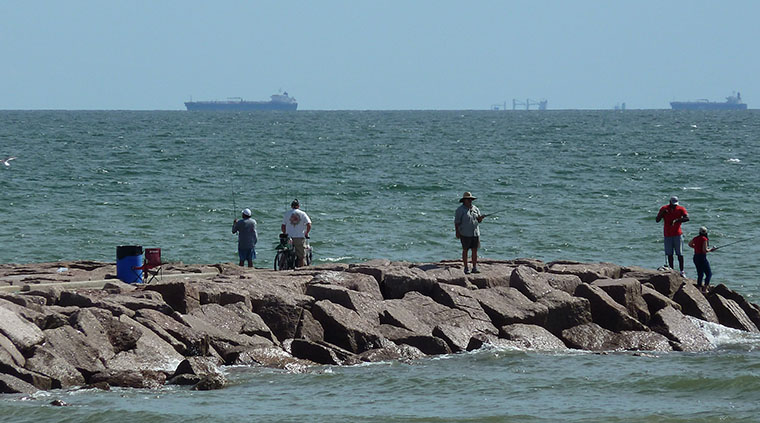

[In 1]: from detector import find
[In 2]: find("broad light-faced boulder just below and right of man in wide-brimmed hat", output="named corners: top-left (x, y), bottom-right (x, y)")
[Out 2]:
top-left (471, 287), bottom-right (549, 327)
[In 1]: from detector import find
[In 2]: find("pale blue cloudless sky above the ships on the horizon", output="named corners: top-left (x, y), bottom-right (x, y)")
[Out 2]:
top-left (0, 0), bottom-right (760, 110)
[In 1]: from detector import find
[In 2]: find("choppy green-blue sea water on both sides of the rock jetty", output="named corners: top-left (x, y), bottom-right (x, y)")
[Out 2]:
top-left (0, 110), bottom-right (760, 422)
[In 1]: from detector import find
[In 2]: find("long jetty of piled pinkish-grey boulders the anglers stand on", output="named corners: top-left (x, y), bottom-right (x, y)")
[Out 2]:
top-left (0, 259), bottom-right (760, 393)
